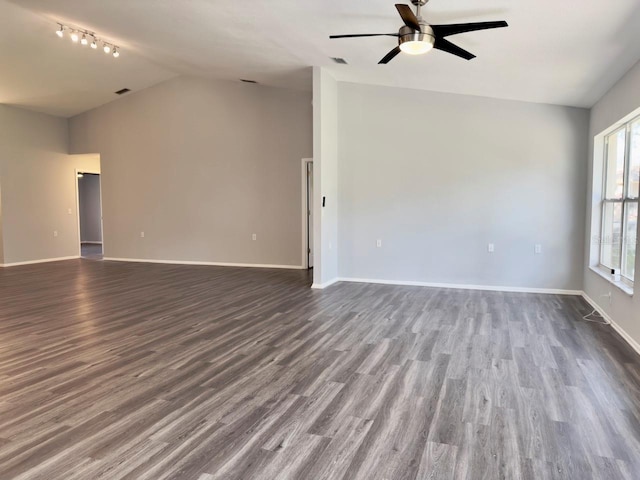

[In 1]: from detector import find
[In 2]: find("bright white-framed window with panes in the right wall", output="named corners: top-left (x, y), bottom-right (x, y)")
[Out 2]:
top-left (600, 118), bottom-right (640, 282)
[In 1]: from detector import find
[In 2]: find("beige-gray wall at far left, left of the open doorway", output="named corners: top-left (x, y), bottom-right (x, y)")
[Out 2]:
top-left (0, 105), bottom-right (78, 264)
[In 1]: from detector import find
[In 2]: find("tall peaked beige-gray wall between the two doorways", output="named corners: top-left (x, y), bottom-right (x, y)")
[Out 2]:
top-left (70, 77), bottom-right (312, 266)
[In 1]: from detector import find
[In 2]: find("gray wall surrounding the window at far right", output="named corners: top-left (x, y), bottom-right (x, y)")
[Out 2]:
top-left (584, 59), bottom-right (640, 343)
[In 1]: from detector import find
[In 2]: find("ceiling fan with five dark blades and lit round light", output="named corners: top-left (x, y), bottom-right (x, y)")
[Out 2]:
top-left (329, 0), bottom-right (509, 64)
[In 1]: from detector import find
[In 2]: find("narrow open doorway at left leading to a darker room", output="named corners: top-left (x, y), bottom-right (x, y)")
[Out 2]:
top-left (76, 172), bottom-right (103, 260)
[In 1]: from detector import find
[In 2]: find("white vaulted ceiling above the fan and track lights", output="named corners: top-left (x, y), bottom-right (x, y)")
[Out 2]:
top-left (0, 0), bottom-right (640, 116)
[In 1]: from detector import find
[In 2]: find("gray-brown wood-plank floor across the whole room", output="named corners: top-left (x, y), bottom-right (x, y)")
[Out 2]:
top-left (0, 260), bottom-right (640, 480)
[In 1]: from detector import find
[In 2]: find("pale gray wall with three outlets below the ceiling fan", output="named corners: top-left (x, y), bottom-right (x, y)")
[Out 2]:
top-left (338, 83), bottom-right (589, 290)
